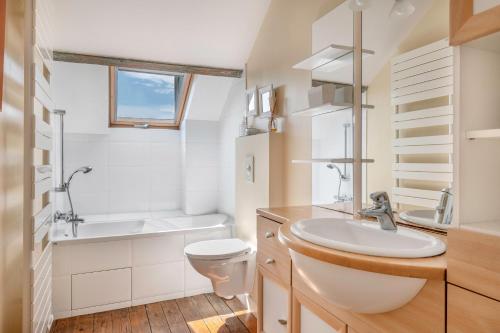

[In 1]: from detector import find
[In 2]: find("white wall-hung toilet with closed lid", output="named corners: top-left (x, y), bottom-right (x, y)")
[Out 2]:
top-left (184, 238), bottom-right (255, 298)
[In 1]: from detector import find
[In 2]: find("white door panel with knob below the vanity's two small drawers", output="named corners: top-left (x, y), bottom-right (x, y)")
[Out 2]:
top-left (262, 276), bottom-right (288, 333)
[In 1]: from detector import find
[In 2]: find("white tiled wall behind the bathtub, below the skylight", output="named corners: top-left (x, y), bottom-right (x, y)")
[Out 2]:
top-left (64, 128), bottom-right (181, 214)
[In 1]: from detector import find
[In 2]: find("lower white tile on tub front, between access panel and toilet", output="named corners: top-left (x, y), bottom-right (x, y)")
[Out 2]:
top-left (132, 260), bottom-right (184, 300)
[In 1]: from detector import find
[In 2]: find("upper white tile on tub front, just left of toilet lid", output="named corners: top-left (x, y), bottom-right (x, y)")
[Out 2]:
top-left (132, 234), bottom-right (184, 266)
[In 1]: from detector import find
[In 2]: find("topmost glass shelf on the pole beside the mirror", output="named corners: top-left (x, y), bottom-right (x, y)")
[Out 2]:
top-left (293, 44), bottom-right (375, 72)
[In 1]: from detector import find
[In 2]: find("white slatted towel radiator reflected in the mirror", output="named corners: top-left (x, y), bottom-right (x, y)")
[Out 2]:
top-left (391, 39), bottom-right (454, 209)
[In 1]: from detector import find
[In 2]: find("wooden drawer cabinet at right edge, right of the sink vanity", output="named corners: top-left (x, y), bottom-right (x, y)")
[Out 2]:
top-left (447, 226), bottom-right (500, 333)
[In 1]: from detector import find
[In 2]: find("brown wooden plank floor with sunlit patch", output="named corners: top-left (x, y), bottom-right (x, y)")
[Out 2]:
top-left (51, 294), bottom-right (257, 333)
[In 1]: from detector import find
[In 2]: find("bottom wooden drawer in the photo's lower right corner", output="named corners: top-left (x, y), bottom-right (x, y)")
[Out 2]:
top-left (447, 284), bottom-right (500, 333)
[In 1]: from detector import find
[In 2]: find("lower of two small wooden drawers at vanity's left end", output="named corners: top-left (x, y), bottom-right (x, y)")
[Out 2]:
top-left (257, 240), bottom-right (292, 285)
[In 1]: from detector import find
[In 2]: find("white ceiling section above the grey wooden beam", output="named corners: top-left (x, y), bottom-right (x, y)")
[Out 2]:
top-left (53, 0), bottom-right (270, 69)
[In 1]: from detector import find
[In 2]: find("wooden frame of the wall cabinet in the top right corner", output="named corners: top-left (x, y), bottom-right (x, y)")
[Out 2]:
top-left (450, 0), bottom-right (500, 46)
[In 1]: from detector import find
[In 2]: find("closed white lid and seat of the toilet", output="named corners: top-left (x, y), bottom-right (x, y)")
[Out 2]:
top-left (184, 238), bottom-right (250, 259)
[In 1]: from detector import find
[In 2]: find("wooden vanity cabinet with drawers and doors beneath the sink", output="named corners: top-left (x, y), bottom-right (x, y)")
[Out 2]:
top-left (257, 216), bottom-right (446, 333)
